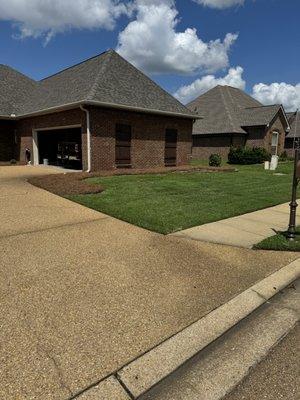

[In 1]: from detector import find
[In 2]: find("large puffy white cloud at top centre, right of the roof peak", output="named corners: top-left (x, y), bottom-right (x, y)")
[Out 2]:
top-left (117, 0), bottom-right (238, 74)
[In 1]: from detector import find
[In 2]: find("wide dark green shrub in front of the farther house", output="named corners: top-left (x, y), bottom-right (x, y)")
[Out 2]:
top-left (228, 147), bottom-right (271, 165)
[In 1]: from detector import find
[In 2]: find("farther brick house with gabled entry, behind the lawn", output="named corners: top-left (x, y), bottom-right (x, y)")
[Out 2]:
top-left (188, 86), bottom-right (289, 159)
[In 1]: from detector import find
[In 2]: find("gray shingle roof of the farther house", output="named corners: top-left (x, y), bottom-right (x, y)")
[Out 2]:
top-left (188, 85), bottom-right (281, 134)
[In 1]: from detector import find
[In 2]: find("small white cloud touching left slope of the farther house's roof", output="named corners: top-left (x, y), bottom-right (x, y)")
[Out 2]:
top-left (174, 67), bottom-right (246, 104)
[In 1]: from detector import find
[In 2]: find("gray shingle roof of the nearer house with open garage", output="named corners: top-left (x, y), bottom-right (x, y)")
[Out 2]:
top-left (0, 50), bottom-right (193, 117)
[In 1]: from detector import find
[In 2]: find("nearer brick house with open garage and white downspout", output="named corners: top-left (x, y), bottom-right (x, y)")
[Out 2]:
top-left (0, 50), bottom-right (197, 171)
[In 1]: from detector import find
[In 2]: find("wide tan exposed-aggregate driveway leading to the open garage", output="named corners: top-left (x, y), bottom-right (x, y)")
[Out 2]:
top-left (0, 167), bottom-right (296, 400)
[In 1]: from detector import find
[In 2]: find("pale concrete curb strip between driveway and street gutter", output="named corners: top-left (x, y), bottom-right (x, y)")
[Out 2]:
top-left (74, 258), bottom-right (300, 400)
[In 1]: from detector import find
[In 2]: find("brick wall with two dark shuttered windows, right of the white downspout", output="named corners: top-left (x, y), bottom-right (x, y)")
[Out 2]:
top-left (90, 107), bottom-right (192, 171)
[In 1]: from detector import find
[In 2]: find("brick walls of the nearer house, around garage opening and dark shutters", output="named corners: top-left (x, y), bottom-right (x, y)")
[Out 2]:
top-left (16, 107), bottom-right (192, 171)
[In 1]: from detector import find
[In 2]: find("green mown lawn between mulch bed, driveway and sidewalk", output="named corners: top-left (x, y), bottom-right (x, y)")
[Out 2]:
top-left (69, 163), bottom-right (292, 234)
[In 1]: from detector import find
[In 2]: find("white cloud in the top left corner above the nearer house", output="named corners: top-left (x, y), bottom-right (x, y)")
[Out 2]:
top-left (0, 0), bottom-right (129, 41)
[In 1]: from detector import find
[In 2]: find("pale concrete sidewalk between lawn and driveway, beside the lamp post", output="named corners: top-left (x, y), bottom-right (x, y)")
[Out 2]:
top-left (170, 203), bottom-right (300, 248)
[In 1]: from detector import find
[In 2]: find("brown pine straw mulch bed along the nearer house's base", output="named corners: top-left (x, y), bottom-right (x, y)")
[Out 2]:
top-left (28, 165), bottom-right (236, 196)
